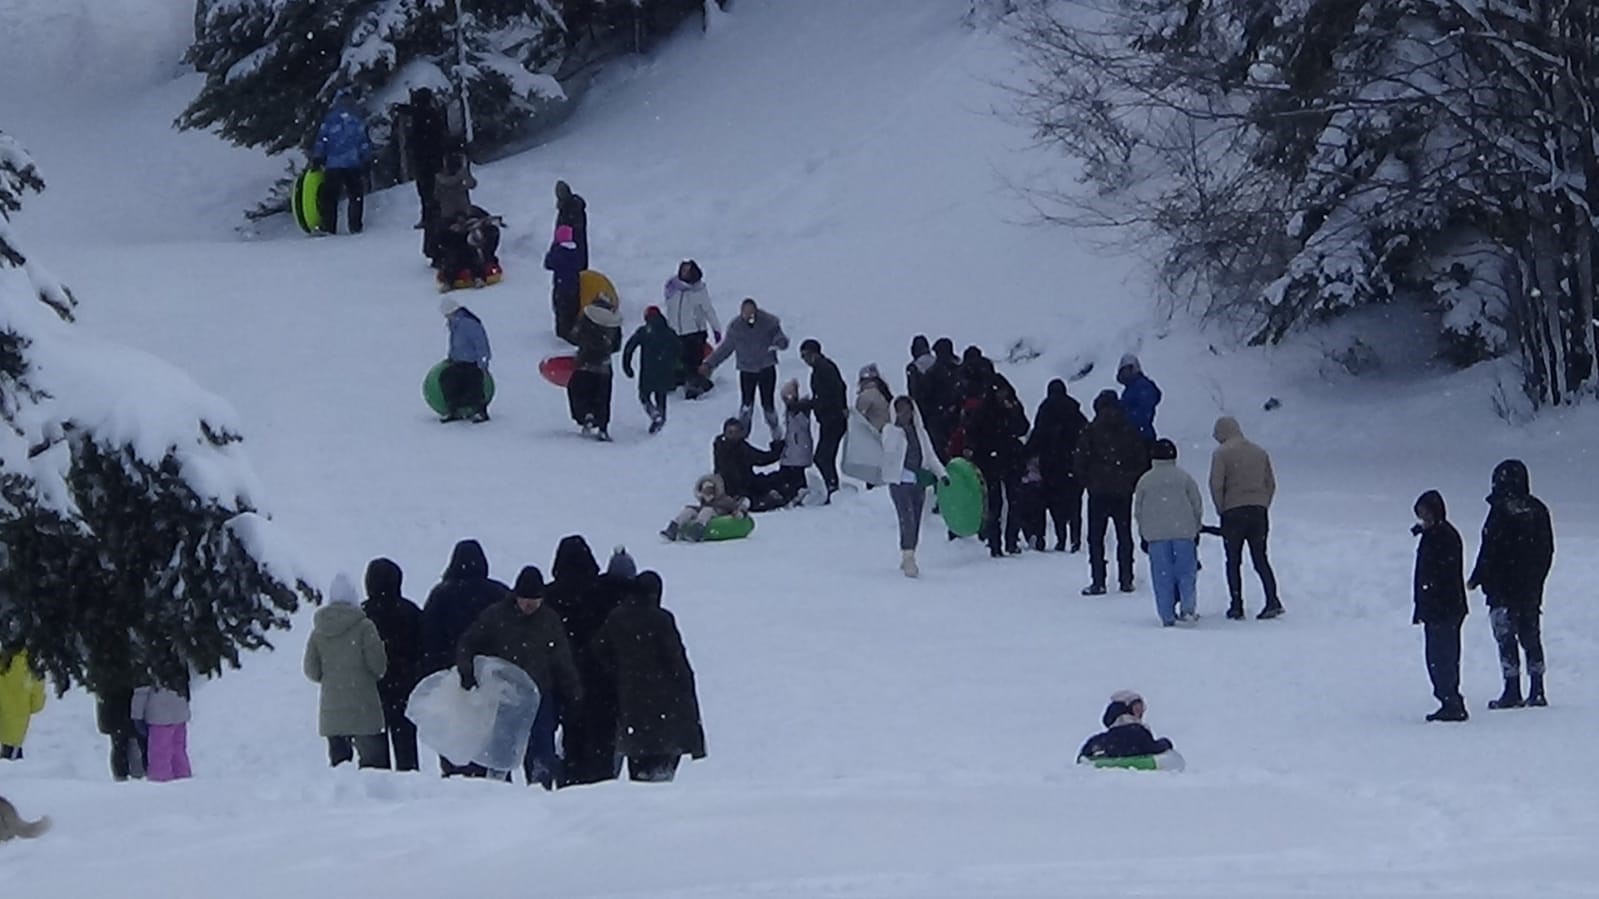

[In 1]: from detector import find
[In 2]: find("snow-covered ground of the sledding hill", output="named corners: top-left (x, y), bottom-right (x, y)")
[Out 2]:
top-left (0, 0), bottom-right (1599, 899)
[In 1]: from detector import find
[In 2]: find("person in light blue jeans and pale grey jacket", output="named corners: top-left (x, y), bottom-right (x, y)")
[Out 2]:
top-left (1132, 440), bottom-right (1204, 627)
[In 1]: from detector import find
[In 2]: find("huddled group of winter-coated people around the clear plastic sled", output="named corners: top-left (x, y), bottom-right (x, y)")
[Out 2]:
top-left (305, 536), bottom-right (705, 789)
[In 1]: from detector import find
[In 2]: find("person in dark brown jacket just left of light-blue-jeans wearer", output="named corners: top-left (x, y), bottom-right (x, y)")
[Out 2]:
top-left (1071, 390), bottom-right (1150, 597)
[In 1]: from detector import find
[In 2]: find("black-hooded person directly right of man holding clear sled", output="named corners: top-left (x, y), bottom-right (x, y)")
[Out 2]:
top-left (545, 534), bottom-right (632, 787)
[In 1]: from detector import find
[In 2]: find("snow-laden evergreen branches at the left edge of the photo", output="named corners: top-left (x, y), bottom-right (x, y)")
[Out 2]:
top-left (0, 133), bottom-right (315, 689)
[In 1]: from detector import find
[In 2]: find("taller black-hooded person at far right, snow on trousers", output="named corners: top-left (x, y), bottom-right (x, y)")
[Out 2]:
top-left (1466, 459), bottom-right (1554, 709)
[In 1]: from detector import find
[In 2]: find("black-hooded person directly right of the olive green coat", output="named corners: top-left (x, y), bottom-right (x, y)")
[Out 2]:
top-left (361, 558), bottom-right (422, 771)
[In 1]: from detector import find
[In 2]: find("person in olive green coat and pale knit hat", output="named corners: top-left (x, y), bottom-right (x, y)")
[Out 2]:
top-left (305, 574), bottom-right (389, 768)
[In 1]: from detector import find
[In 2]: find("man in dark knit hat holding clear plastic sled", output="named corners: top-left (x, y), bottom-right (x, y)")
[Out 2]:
top-left (456, 565), bottom-right (582, 790)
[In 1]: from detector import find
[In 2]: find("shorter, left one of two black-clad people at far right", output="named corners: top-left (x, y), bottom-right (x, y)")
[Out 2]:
top-left (1410, 489), bottom-right (1469, 721)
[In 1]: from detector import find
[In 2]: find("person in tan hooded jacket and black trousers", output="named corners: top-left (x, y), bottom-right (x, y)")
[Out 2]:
top-left (1210, 416), bottom-right (1282, 619)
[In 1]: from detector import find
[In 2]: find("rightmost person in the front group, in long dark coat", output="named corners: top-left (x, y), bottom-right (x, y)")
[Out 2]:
top-left (593, 571), bottom-right (705, 782)
